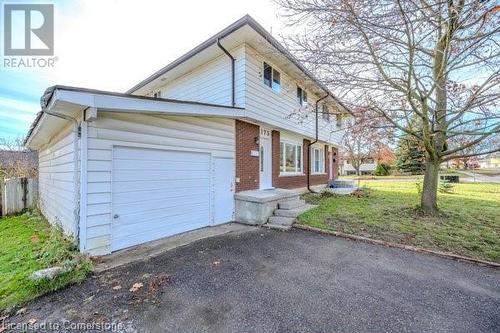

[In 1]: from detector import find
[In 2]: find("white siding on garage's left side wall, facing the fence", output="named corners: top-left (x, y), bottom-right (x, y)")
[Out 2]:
top-left (38, 125), bottom-right (78, 236)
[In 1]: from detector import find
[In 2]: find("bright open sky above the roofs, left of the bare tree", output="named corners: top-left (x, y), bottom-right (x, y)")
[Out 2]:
top-left (0, 0), bottom-right (283, 139)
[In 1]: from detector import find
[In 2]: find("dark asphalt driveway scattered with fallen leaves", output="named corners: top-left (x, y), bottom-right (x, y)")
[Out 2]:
top-left (6, 229), bottom-right (500, 333)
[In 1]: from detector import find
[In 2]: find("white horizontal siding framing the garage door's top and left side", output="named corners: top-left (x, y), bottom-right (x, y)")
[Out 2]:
top-left (86, 112), bottom-right (235, 255)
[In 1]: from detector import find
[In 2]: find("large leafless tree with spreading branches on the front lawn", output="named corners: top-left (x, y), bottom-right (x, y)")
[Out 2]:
top-left (276, 0), bottom-right (500, 214)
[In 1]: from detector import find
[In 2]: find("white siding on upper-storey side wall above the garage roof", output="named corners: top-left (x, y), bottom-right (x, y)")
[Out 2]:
top-left (161, 46), bottom-right (245, 107)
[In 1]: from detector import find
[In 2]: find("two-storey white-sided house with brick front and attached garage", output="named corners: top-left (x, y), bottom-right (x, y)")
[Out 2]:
top-left (26, 16), bottom-right (348, 255)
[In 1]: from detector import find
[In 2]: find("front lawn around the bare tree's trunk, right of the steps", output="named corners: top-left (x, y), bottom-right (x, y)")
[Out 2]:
top-left (299, 180), bottom-right (500, 262)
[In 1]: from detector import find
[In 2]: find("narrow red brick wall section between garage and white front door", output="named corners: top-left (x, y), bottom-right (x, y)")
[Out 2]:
top-left (235, 120), bottom-right (258, 192)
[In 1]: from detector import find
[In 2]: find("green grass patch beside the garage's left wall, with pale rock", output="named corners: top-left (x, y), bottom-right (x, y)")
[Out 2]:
top-left (0, 212), bottom-right (92, 310)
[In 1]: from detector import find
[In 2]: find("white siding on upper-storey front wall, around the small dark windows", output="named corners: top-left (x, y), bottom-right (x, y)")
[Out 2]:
top-left (245, 45), bottom-right (343, 144)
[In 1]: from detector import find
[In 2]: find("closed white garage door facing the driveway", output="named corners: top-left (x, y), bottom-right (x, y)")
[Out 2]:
top-left (112, 147), bottom-right (210, 251)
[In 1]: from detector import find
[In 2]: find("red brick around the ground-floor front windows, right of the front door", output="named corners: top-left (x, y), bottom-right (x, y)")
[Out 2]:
top-left (272, 131), bottom-right (329, 188)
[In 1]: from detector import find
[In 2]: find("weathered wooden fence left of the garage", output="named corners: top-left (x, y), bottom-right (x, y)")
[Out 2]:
top-left (0, 178), bottom-right (38, 216)
